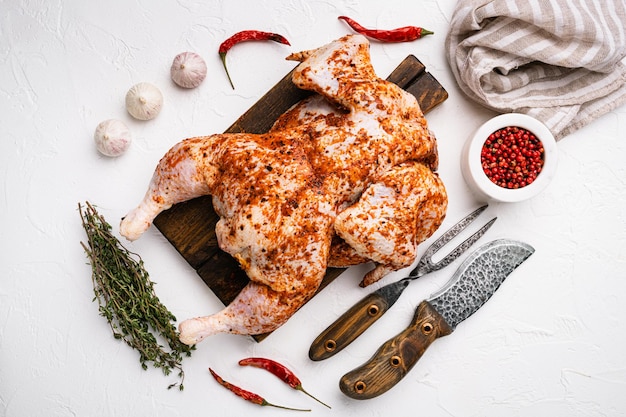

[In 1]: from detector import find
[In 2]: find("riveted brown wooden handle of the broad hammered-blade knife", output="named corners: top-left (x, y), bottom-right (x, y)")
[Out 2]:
top-left (339, 301), bottom-right (452, 400)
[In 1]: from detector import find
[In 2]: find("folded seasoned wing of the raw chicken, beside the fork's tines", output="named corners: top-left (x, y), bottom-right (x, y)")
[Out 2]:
top-left (329, 161), bottom-right (447, 286)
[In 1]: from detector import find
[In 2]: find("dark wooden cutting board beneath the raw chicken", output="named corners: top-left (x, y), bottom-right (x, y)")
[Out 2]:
top-left (154, 55), bottom-right (448, 341)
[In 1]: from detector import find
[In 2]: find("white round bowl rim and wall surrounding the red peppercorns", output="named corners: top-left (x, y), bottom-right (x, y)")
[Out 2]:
top-left (461, 113), bottom-right (557, 203)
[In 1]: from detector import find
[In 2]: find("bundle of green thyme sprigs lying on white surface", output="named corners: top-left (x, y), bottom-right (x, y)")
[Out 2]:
top-left (78, 202), bottom-right (194, 391)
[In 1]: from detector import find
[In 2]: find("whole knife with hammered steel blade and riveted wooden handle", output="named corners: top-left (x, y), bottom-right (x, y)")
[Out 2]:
top-left (339, 239), bottom-right (535, 400)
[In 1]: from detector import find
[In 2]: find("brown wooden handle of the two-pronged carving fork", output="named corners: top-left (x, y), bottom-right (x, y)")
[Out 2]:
top-left (309, 291), bottom-right (391, 361)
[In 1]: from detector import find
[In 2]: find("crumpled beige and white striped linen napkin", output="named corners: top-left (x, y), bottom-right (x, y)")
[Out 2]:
top-left (446, 0), bottom-right (626, 140)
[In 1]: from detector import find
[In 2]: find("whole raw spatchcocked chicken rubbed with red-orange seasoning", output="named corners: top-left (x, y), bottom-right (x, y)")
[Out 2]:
top-left (120, 35), bottom-right (447, 344)
